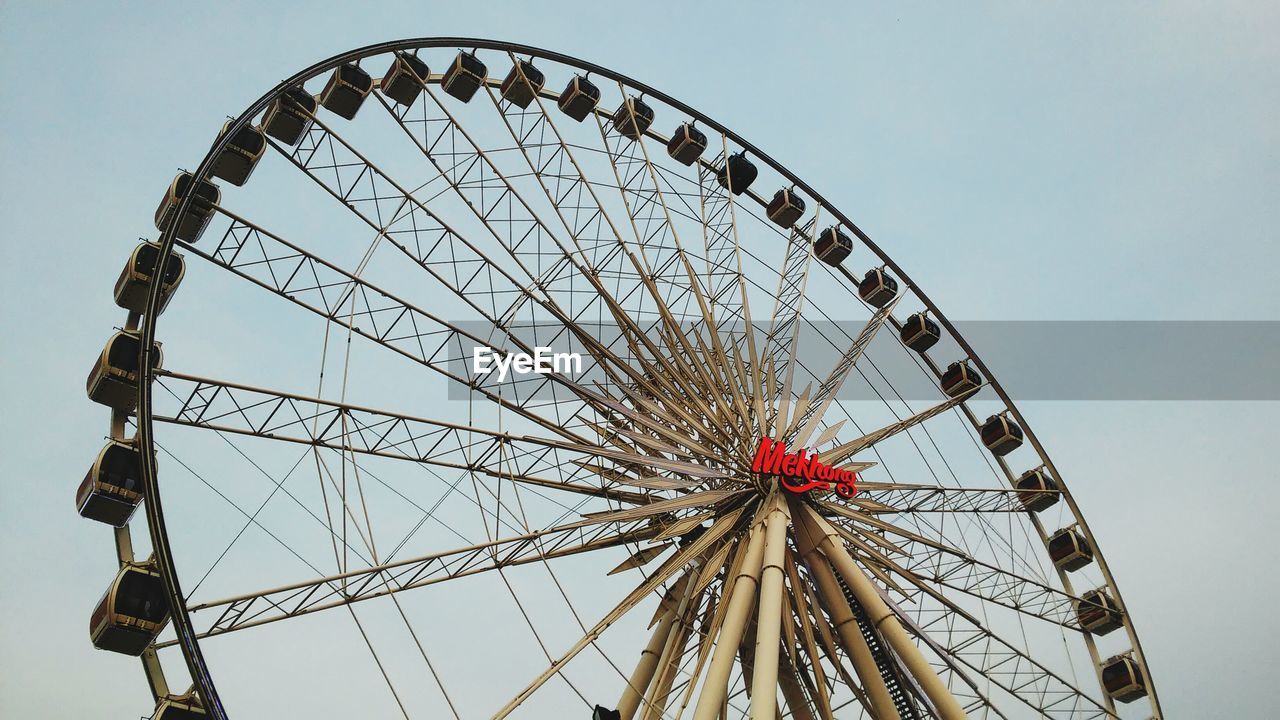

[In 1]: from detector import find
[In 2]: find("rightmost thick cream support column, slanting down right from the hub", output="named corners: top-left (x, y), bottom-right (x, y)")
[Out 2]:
top-left (800, 505), bottom-right (968, 720)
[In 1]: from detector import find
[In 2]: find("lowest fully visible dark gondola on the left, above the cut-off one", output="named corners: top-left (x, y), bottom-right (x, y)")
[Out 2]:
top-left (88, 562), bottom-right (169, 656)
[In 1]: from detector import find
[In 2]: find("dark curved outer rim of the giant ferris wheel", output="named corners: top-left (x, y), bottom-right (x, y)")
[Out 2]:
top-left (136, 37), bottom-right (1162, 720)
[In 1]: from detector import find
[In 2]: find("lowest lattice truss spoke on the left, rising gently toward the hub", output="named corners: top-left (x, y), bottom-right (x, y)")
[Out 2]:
top-left (177, 509), bottom-right (662, 638)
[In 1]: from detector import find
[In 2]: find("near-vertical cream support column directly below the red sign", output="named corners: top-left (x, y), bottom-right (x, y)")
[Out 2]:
top-left (751, 492), bottom-right (791, 720)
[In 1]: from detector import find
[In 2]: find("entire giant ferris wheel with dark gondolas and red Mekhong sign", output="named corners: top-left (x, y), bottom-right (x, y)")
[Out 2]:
top-left (77, 38), bottom-right (1161, 720)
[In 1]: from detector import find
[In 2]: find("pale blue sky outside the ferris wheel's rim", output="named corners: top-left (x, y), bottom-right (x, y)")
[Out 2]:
top-left (0, 1), bottom-right (1280, 717)
